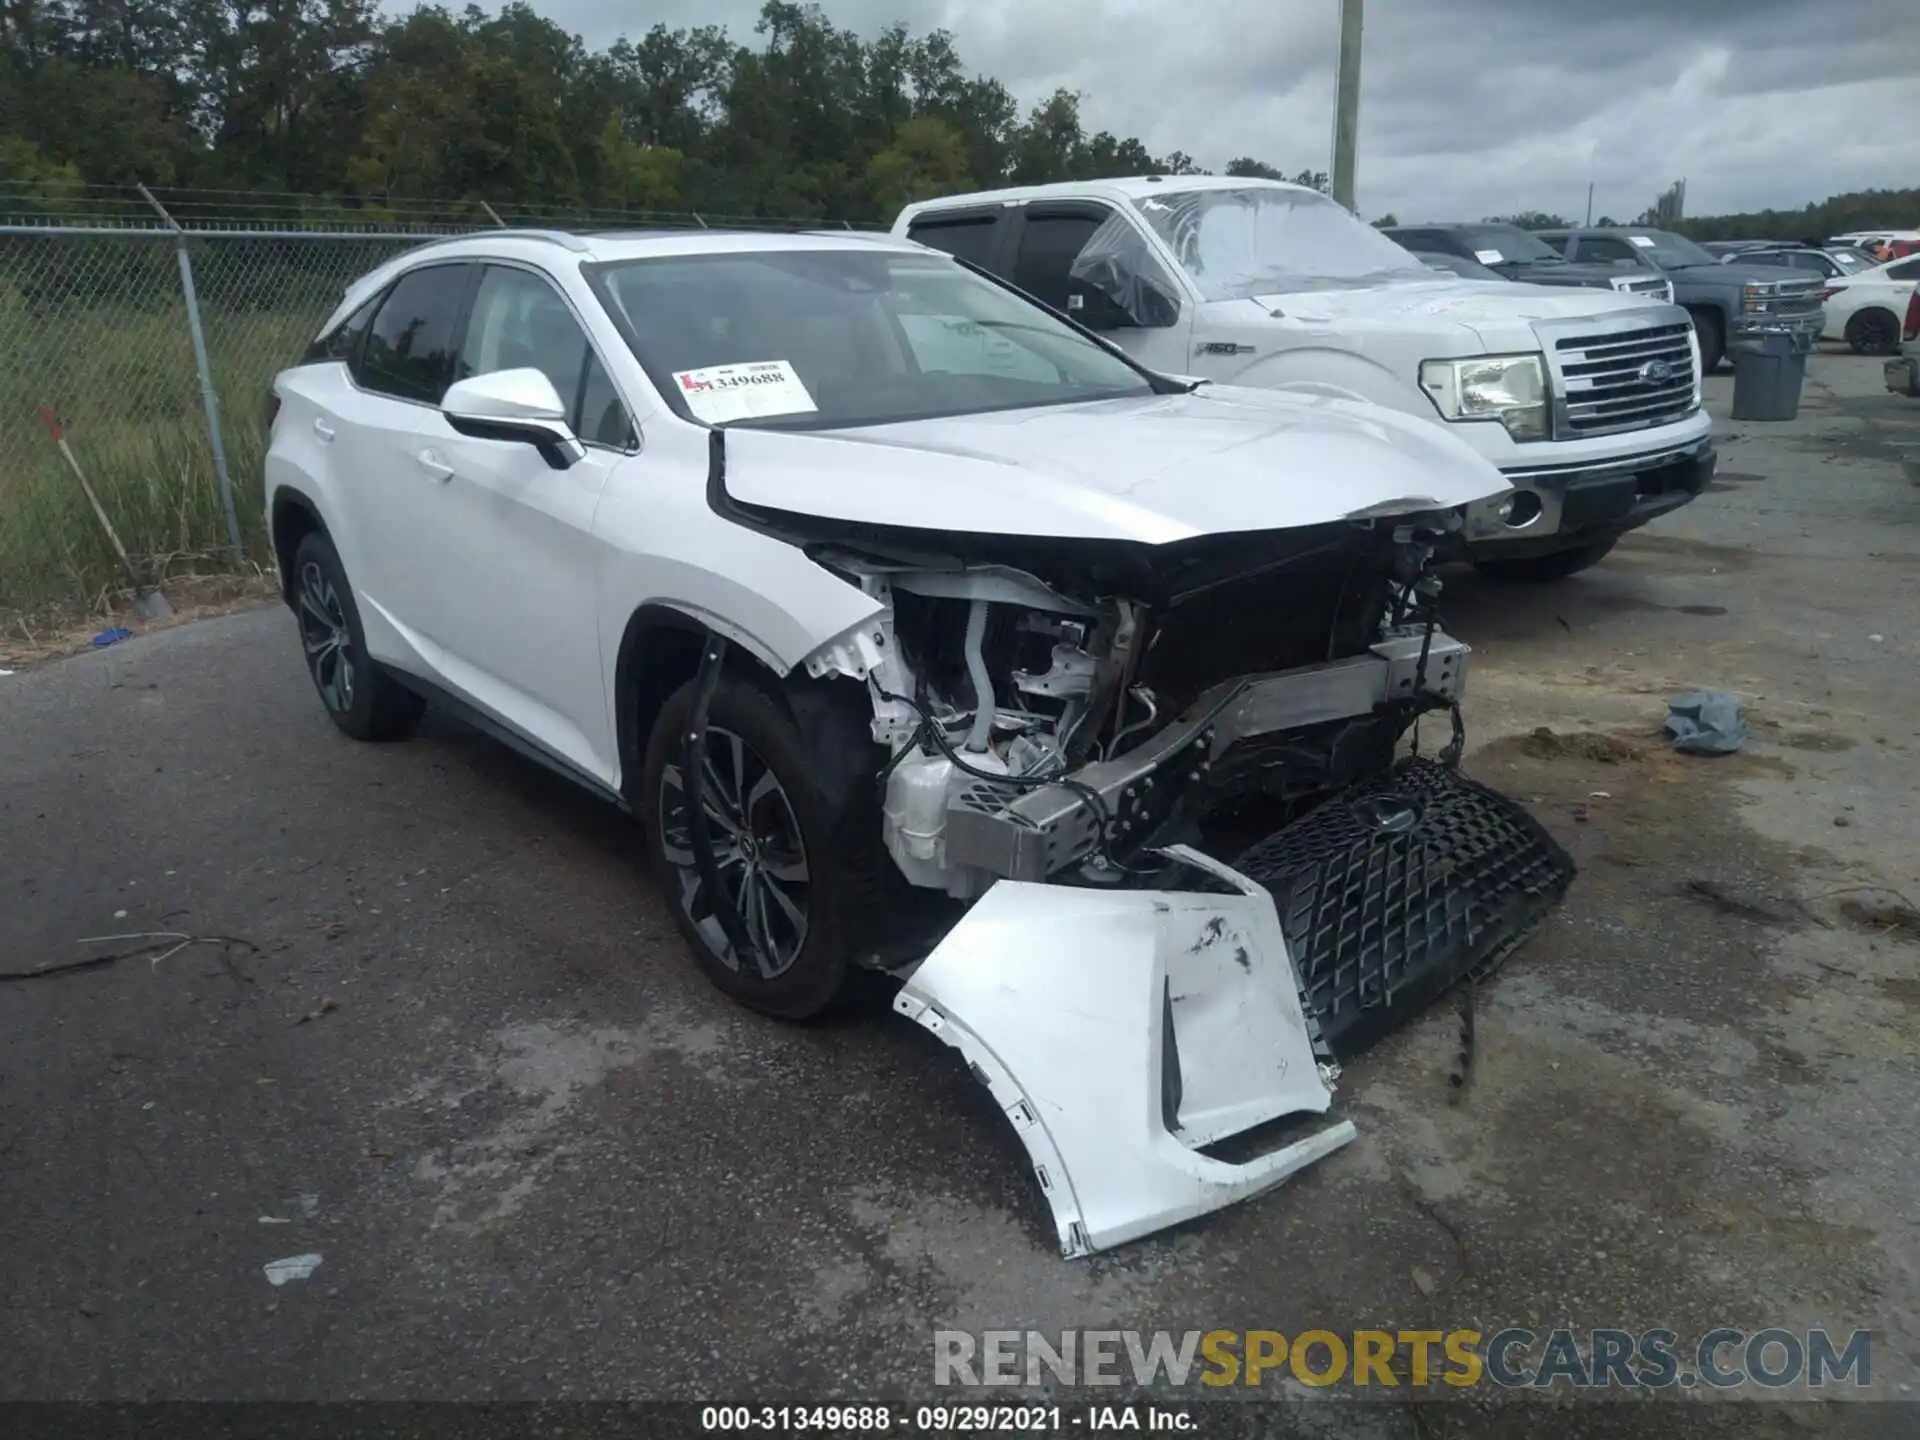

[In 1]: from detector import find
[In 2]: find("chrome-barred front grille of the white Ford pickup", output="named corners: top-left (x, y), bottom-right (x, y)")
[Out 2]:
top-left (1548, 315), bottom-right (1699, 438)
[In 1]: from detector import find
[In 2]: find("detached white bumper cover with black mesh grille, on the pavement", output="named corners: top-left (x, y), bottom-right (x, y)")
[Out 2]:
top-left (895, 760), bottom-right (1574, 1260)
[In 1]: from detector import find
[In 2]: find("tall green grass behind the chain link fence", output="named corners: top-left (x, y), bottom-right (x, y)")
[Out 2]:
top-left (0, 234), bottom-right (419, 611)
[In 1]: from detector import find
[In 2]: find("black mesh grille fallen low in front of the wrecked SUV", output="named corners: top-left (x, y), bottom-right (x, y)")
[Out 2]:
top-left (1235, 760), bottom-right (1574, 1058)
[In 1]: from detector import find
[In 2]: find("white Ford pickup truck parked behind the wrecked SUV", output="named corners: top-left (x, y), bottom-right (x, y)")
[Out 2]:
top-left (893, 175), bottom-right (1715, 580)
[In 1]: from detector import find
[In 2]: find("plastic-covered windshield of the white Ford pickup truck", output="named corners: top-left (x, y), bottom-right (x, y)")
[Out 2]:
top-left (1133, 184), bottom-right (1434, 300)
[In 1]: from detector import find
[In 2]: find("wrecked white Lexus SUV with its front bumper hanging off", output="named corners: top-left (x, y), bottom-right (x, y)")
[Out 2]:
top-left (265, 232), bottom-right (1572, 1256)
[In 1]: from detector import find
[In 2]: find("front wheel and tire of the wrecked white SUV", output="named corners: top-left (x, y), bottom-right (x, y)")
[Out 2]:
top-left (641, 674), bottom-right (879, 1020)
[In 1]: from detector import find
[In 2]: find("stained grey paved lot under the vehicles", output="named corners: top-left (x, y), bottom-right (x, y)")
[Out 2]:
top-left (0, 355), bottom-right (1920, 1436)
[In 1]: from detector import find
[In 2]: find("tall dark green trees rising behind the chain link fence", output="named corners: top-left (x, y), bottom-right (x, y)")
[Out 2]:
top-left (0, 0), bottom-right (1327, 219)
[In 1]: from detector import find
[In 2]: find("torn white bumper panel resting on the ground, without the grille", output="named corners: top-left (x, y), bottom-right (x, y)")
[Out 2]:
top-left (893, 847), bottom-right (1356, 1260)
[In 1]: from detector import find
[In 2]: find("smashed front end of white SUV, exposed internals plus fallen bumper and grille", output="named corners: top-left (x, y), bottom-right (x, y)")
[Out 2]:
top-left (689, 433), bottom-right (1572, 1258)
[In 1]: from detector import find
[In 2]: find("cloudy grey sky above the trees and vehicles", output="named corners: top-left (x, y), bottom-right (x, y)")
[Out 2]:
top-left (491, 0), bottom-right (1920, 225)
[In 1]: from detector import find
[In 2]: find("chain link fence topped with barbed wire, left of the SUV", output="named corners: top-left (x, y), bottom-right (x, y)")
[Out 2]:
top-left (0, 192), bottom-right (877, 612)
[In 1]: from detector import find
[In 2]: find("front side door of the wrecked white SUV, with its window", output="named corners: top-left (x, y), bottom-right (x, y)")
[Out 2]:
top-left (409, 263), bottom-right (637, 785)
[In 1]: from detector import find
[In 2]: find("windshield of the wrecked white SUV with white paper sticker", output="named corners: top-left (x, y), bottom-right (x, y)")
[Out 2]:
top-left (589, 250), bottom-right (1154, 430)
